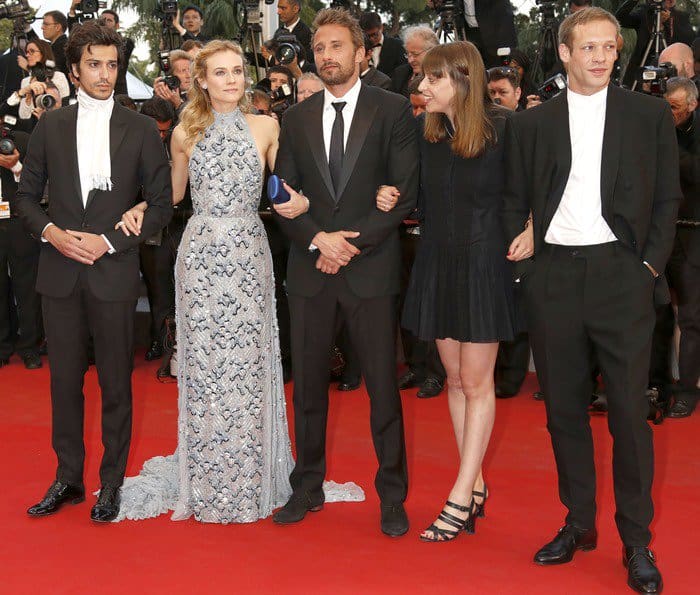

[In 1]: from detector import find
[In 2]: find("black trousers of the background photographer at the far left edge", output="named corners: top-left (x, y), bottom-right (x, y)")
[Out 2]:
top-left (0, 218), bottom-right (41, 359)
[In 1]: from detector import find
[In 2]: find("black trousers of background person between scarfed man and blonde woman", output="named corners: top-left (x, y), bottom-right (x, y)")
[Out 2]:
top-left (139, 219), bottom-right (185, 343)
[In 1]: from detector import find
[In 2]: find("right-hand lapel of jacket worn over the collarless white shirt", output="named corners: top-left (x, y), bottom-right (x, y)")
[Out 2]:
top-left (600, 85), bottom-right (624, 221)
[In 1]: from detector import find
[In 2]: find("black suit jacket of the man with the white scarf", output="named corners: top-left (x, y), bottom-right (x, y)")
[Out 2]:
top-left (12, 104), bottom-right (172, 301)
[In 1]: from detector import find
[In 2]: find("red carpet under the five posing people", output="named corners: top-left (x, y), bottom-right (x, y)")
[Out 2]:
top-left (0, 354), bottom-right (700, 595)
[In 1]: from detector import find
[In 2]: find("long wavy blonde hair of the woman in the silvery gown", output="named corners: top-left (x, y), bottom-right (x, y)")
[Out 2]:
top-left (180, 39), bottom-right (250, 150)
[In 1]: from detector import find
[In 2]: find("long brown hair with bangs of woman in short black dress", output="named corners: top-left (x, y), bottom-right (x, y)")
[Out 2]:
top-left (423, 41), bottom-right (496, 158)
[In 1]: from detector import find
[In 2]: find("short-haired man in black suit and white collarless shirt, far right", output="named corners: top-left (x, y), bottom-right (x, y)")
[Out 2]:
top-left (504, 8), bottom-right (681, 593)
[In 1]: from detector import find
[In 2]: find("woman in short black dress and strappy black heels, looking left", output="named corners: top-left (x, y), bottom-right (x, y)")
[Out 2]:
top-left (377, 42), bottom-right (532, 541)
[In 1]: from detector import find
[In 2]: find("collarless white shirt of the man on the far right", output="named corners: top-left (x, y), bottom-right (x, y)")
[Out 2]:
top-left (544, 87), bottom-right (617, 246)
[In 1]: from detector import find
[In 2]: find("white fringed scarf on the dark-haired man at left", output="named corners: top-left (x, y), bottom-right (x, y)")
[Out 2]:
top-left (76, 89), bottom-right (114, 198)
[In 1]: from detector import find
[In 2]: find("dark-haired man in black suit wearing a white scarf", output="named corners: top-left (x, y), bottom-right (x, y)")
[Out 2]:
top-left (12, 22), bottom-right (172, 521)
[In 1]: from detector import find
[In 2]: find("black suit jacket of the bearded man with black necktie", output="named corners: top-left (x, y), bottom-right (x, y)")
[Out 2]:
top-left (275, 84), bottom-right (419, 298)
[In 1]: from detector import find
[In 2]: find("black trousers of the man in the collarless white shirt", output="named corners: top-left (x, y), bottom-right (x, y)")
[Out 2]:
top-left (525, 242), bottom-right (655, 547)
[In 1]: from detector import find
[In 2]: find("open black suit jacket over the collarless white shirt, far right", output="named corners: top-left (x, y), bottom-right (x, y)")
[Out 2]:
top-left (504, 85), bottom-right (681, 303)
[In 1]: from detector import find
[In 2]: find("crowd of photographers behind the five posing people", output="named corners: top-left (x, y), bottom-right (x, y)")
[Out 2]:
top-left (0, 0), bottom-right (700, 417)
